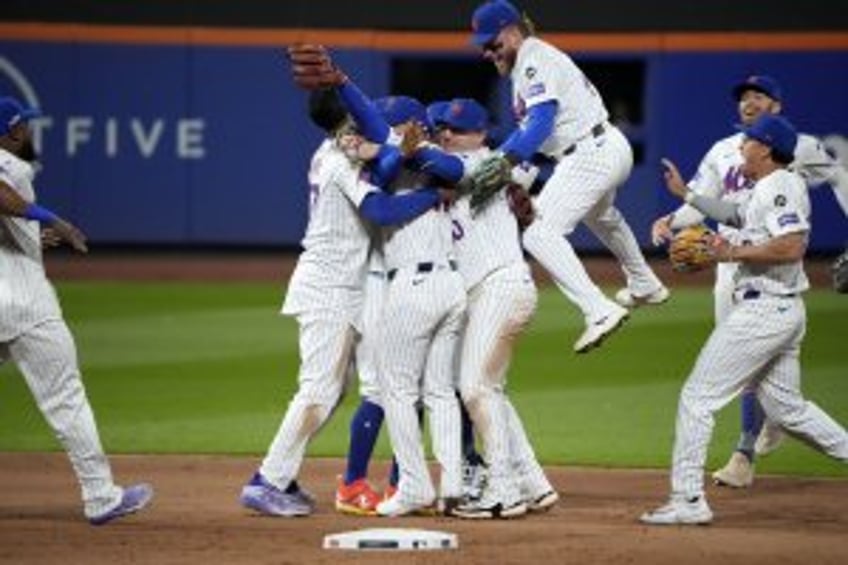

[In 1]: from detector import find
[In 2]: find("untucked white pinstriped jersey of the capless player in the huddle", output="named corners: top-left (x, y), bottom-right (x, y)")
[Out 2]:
top-left (282, 139), bottom-right (377, 322)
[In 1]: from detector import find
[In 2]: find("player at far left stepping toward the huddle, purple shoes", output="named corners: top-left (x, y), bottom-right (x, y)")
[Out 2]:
top-left (0, 97), bottom-right (153, 526)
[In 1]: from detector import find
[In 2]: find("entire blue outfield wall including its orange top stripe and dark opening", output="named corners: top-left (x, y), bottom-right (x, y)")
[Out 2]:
top-left (0, 23), bottom-right (848, 248)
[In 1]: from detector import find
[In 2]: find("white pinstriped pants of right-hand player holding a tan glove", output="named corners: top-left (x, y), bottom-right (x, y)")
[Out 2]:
top-left (671, 295), bottom-right (848, 498)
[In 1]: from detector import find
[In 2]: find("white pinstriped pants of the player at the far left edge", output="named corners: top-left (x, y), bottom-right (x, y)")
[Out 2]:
top-left (0, 319), bottom-right (123, 518)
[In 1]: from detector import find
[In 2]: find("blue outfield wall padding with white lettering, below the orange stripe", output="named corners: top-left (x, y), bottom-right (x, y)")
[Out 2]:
top-left (0, 40), bottom-right (848, 252)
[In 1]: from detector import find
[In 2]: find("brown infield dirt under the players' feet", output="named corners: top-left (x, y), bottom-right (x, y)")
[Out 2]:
top-left (0, 453), bottom-right (848, 565)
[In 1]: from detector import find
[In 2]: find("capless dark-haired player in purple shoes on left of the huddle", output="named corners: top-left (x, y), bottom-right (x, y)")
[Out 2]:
top-left (241, 89), bottom-right (450, 516)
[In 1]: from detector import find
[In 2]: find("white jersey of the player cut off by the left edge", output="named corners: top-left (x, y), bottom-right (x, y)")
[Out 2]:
top-left (0, 149), bottom-right (61, 341)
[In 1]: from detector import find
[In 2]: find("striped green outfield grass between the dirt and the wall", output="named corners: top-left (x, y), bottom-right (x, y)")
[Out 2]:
top-left (0, 282), bottom-right (848, 477)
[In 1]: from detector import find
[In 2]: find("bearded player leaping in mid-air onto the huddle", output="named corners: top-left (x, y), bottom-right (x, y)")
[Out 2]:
top-left (464, 0), bottom-right (668, 353)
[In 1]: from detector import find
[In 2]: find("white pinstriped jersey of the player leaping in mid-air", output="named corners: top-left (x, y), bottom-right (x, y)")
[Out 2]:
top-left (511, 37), bottom-right (609, 157)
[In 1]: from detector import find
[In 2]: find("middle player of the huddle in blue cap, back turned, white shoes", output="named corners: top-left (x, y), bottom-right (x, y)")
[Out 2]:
top-left (356, 96), bottom-right (466, 516)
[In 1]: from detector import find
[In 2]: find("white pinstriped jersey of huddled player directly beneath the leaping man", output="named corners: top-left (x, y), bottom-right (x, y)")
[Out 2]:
top-left (450, 147), bottom-right (524, 288)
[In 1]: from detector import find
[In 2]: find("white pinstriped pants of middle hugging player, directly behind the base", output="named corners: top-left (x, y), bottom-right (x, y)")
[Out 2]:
top-left (378, 267), bottom-right (466, 504)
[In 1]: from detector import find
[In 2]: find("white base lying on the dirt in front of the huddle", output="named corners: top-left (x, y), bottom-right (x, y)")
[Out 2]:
top-left (324, 528), bottom-right (459, 551)
